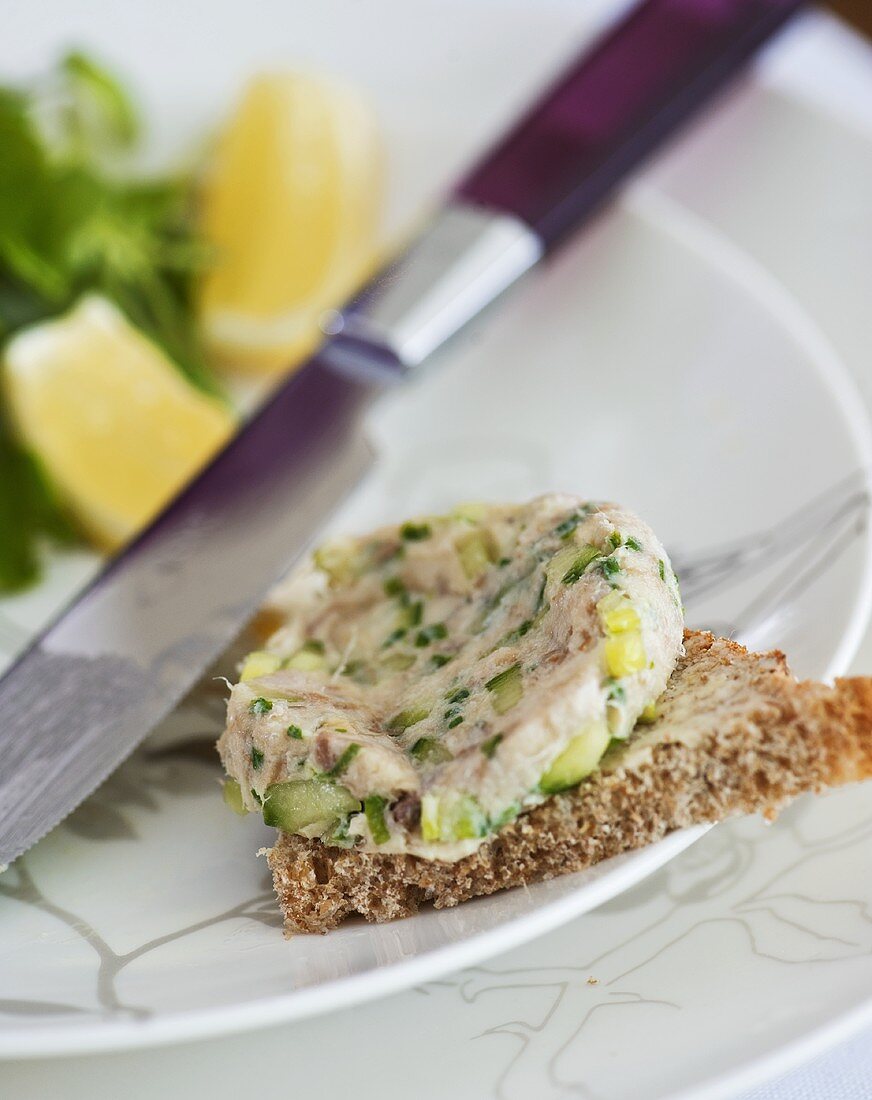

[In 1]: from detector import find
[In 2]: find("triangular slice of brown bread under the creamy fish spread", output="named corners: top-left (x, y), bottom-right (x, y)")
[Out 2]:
top-left (267, 631), bottom-right (872, 933)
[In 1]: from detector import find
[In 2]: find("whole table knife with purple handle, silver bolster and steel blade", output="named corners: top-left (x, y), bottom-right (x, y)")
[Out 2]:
top-left (0, 0), bottom-right (801, 865)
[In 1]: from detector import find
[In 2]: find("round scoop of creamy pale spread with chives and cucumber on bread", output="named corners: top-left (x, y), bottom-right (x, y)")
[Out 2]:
top-left (219, 494), bottom-right (683, 859)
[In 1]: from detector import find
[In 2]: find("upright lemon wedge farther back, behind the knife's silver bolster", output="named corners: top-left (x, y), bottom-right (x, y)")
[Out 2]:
top-left (199, 74), bottom-right (382, 373)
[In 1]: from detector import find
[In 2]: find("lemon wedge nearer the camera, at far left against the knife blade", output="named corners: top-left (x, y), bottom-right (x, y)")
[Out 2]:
top-left (2, 296), bottom-right (234, 549)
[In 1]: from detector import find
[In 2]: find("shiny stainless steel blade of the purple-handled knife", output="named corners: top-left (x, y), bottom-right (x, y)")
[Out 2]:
top-left (0, 360), bottom-right (380, 864)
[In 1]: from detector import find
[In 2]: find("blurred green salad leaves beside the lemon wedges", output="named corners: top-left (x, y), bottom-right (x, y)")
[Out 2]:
top-left (0, 52), bottom-right (220, 593)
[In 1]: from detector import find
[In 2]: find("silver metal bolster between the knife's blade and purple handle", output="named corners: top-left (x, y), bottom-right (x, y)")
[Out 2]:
top-left (321, 200), bottom-right (536, 373)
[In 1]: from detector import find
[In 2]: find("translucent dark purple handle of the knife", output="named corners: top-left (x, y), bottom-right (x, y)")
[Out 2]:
top-left (456, 0), bottom-right (802, 249)
